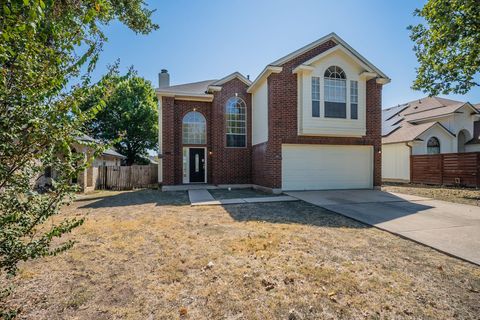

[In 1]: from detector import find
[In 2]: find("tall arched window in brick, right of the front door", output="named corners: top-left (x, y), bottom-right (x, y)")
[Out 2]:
top-left (225, 97), bottom-right (247, 148)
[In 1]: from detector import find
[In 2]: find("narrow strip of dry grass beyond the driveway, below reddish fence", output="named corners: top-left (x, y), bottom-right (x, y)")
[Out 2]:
top-left (382, 183), bottom-right (480, 206)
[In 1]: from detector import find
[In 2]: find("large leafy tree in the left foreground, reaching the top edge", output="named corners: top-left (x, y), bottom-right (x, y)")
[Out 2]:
top-left (0, 0), bottom-right (157, 292)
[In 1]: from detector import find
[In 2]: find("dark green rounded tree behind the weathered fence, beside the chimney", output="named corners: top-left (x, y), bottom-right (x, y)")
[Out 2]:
top-left (82, 65), bottom-right (158, 165)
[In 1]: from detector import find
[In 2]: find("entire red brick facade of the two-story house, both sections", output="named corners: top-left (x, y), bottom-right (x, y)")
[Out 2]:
top-left (162, 40), bottom-right (382, 189)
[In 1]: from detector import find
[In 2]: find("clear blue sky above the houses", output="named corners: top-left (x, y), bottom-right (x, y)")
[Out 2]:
top-left (94, 0), bottom-right (480, 108)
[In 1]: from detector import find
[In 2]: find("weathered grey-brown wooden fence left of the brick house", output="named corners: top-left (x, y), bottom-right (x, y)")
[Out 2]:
top-left (96, 164), bottom-right (158, 190)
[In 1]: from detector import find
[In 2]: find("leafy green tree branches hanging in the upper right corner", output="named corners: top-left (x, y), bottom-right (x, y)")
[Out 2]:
top-left (408, 0), bottom-right (480, 95)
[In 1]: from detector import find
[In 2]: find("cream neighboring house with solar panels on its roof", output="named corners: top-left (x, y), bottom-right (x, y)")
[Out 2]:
top-left (382, 97), bottom-right (480, 181)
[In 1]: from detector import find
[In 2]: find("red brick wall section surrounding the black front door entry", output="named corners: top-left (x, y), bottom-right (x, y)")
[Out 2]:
top-left (162, 79), bottom-right (252, 185)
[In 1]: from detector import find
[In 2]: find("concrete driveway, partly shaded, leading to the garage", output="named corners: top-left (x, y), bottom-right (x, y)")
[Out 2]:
top-left (287, 190), bottom-right (480, 265)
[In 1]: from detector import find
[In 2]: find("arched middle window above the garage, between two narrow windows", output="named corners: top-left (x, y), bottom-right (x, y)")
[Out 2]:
top-left (324, 66), bottom-right (347, 119)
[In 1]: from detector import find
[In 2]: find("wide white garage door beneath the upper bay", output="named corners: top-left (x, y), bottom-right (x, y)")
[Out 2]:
top-left (282, 144), bottom-right (373, 190)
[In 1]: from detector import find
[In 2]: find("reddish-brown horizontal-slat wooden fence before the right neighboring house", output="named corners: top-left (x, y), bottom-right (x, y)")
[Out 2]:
top-left (410, 152), bottom-right (480, 188)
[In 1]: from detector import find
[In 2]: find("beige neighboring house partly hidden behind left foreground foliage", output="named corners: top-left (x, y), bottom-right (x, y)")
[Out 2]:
top-left (36, 134), bottom-right (127, 192)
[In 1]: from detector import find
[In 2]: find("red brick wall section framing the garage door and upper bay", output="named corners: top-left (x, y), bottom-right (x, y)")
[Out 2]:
top-left (253, 41), bottom-right (382, 188)
